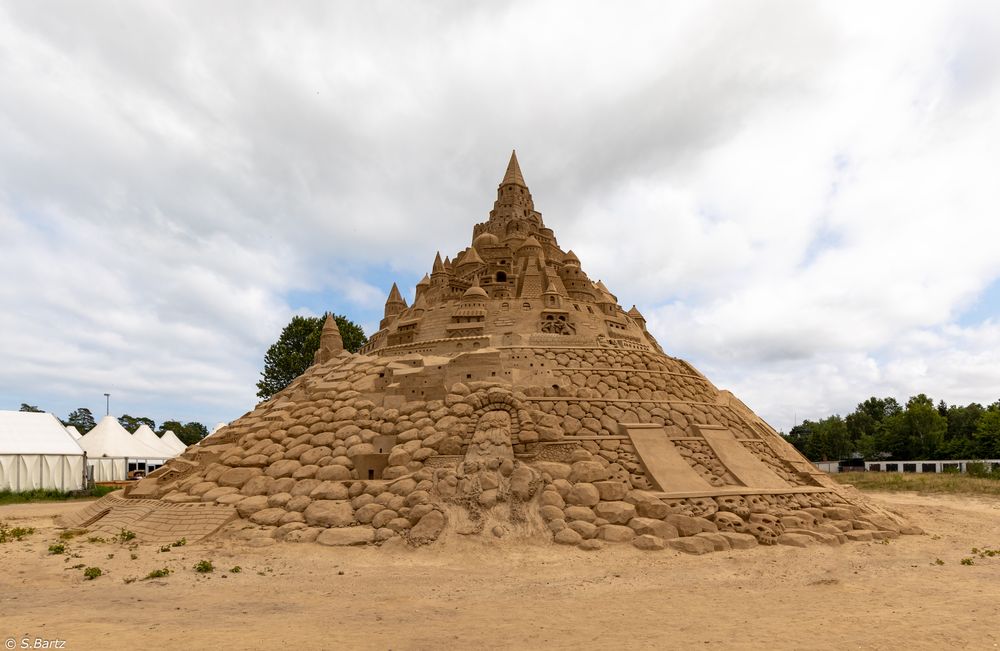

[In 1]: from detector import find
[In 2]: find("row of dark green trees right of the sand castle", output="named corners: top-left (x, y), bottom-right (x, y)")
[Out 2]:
top-left (783, 393), bottom-right (1000, 461)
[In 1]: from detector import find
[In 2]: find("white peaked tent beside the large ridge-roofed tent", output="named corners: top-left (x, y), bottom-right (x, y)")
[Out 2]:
top-left (79, 416), bottom-right (172, 481)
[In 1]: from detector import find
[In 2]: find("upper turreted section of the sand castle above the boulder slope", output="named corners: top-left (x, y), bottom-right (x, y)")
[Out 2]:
top-left (362, 154), bottom-right (662, 355)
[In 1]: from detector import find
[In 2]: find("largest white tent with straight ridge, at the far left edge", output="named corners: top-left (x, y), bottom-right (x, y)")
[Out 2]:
top-left (0, 411), bottom-right (86, 492)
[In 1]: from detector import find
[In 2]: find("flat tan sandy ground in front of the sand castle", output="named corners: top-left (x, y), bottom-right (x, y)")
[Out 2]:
top-left (0, 493), bottom-right (1000, 649)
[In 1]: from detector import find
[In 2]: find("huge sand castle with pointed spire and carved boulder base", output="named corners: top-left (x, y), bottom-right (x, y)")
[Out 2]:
top-left (64, 155), bottom-right (918, 553)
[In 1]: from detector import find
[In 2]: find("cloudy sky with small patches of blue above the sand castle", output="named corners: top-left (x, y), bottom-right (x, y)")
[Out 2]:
top-left (0, 0), bottom-right (1000, 431)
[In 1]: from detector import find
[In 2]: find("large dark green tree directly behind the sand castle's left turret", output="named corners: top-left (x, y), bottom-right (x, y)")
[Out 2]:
top-left (257, 314), bottom-right (367, 400)
